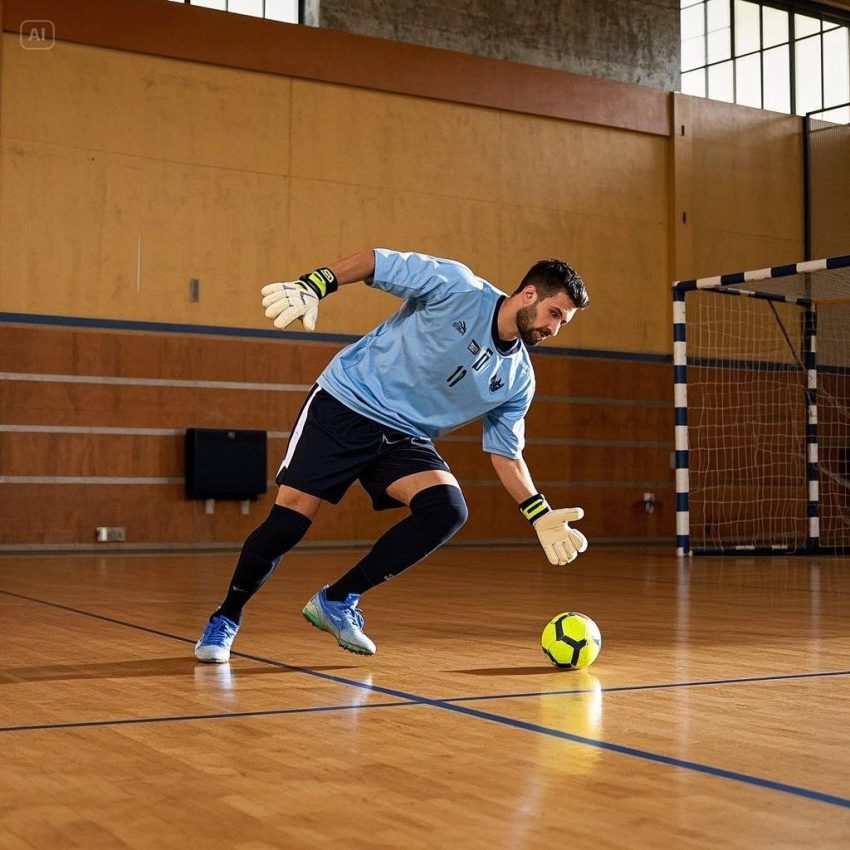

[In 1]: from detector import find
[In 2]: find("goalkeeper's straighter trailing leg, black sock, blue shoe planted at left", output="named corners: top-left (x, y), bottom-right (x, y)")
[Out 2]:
top-left (195, 486), bottom-right (321, 663)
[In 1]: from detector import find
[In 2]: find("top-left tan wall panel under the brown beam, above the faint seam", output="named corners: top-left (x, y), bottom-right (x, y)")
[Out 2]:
top-left (2, 38), bottom-right (292, 174)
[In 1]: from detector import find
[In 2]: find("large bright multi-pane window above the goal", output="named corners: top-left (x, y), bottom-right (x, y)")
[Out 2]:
top-left (680, 0), bottom-right (850, 120)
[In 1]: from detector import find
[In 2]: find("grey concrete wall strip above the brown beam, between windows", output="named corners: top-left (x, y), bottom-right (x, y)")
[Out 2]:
top-left (306, 0), bottom-right (680, 90)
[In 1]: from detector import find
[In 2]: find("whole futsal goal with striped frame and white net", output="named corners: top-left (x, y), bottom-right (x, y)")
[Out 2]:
top-left (673, 255), bottom-right (850, 555)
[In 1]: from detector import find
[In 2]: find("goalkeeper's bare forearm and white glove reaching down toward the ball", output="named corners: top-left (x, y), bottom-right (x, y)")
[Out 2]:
top-left (490, 454), bottom-right (587, 564)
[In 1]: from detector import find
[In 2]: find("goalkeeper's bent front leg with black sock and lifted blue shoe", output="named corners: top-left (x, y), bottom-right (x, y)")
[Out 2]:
top-left (303, 470), bottom-right (467, 655)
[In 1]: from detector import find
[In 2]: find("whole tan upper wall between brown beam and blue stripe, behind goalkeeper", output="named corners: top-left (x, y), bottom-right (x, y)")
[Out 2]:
top-left (0, 34), bottom-right (670, 353)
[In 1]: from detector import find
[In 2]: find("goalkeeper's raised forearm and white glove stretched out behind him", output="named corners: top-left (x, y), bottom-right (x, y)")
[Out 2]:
top-left (260, 251), bottom-right (375, 331)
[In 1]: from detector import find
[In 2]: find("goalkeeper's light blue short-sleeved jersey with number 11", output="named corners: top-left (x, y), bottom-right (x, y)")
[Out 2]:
top-left (318, 248), bottom-right (534, 458)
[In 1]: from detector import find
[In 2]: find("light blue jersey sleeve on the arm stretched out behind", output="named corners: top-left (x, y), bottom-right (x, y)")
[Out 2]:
top-left (366, 248), bottom-right (481, 301)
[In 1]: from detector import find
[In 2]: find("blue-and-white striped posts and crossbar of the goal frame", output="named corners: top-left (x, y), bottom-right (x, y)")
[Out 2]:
top-left (673, 254), bottom-right (850, 555)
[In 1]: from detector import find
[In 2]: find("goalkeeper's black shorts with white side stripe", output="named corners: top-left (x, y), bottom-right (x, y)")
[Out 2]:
top-left (275, 385), bottom-right (451, 511)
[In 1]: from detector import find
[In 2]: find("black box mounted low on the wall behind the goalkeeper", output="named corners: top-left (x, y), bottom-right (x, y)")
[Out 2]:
top-left (186, 428), bottom-right (268, 500)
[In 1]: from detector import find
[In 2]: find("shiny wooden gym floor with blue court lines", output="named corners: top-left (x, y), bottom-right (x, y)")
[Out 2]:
top-left (0, 547), bottom-right (850, 850)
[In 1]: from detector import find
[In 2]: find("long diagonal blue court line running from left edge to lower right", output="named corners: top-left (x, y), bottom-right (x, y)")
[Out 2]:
top-left (6, 589), bottom-right (850, 809)
